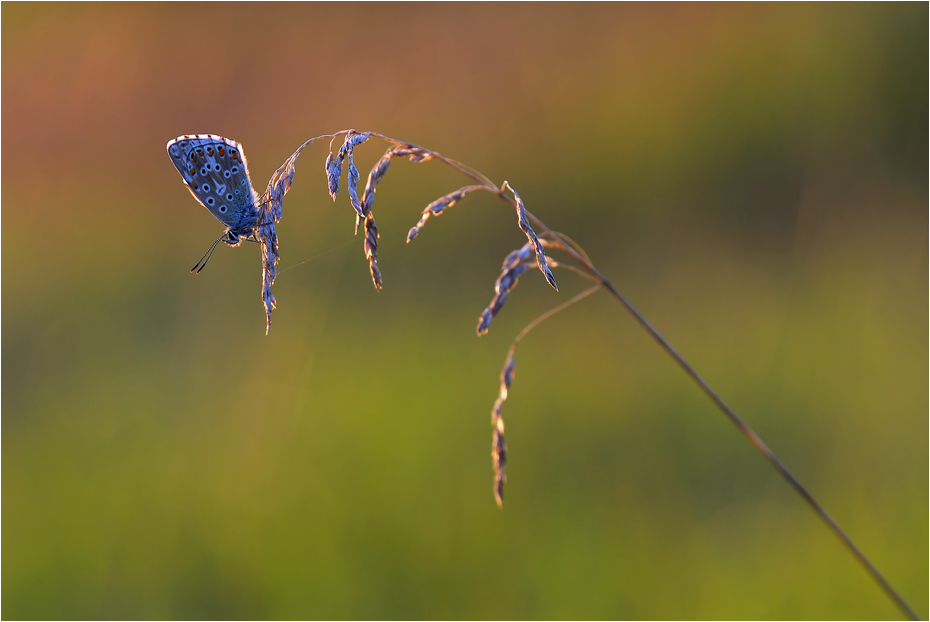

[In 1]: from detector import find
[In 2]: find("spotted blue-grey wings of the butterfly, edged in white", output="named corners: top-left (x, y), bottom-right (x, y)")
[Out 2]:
top-left (168, 134), bottom-right (258, 230)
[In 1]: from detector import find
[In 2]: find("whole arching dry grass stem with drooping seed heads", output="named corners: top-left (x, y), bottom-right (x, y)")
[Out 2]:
top-left (192, 130), bottom-right (919, 619)
